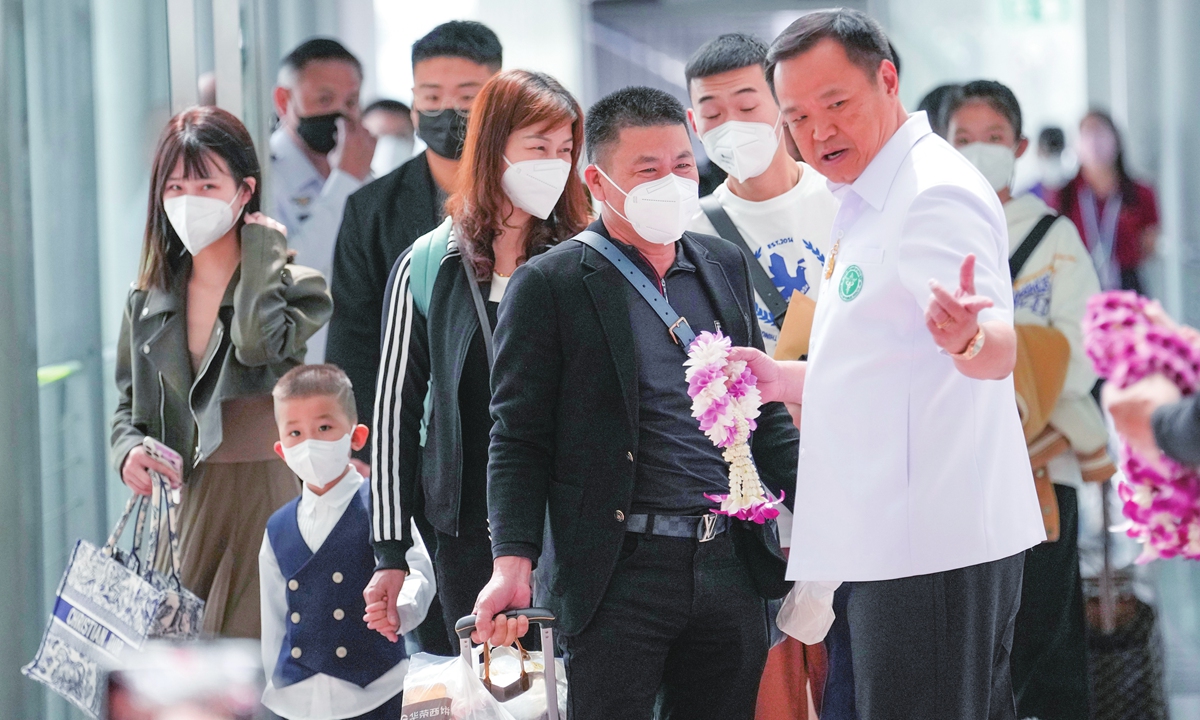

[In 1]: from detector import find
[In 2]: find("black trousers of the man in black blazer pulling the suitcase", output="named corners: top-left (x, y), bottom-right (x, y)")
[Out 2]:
top-left (563, 533), bottom-right (768, 720)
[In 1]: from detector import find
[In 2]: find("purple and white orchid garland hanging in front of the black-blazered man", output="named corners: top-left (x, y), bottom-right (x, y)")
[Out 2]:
top-left (684, 331), bottom-right (782, 524)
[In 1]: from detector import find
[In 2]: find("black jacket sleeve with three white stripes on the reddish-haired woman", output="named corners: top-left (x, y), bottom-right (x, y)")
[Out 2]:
top-left (371, 252), bottom-right (430, 569)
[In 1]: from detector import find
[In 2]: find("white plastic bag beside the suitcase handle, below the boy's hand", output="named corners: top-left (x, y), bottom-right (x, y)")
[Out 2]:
top-left (400, 653), bottom-right (515, 720)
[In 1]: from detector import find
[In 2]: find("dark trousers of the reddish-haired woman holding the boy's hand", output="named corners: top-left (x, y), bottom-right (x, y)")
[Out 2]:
top-left (431, 527), bottom-right (492, 654)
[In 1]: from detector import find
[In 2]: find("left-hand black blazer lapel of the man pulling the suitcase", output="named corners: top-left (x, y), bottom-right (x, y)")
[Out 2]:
top-left (581, 247), bottom-right (638, 429)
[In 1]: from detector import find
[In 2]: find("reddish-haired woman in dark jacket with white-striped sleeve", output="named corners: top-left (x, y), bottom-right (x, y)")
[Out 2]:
top-left (366, 70), bottom-right (589, 646)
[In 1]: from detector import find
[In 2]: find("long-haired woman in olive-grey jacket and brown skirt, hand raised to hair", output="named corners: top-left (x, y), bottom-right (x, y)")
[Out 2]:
top-left (110, 107), bottom-right (332, 637)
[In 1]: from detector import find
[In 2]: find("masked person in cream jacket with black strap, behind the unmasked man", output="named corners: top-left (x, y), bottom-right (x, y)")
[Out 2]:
top-left (948, 80), bottom-right (1114, 720)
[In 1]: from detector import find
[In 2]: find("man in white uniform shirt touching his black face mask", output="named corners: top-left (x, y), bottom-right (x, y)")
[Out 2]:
top-left (271, 37), bottom-right (374, 362)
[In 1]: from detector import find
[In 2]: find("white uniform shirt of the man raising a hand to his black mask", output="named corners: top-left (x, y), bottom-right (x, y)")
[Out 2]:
top-left (268, 127), bottom-right (371, 364)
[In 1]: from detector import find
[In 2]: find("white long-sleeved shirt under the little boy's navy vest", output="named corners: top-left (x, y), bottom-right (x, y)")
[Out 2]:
top-left (258, 467), bottom-right (437, 720)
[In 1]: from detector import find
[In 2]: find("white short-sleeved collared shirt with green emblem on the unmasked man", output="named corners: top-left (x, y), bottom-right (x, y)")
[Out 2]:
top-left (787, 113), bottom-right (1045, 581)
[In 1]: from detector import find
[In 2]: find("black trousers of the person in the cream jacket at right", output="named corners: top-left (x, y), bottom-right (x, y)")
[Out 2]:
top-left (1013, 485), bottom-right (1088, 720)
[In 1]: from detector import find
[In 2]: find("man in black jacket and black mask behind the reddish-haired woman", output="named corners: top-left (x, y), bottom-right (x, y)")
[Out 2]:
top-left (326, 20), bottom-right (502, 655)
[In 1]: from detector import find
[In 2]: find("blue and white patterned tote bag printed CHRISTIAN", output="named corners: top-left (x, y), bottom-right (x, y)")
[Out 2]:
top-left (22, 496), bottom-right (166, 718)
